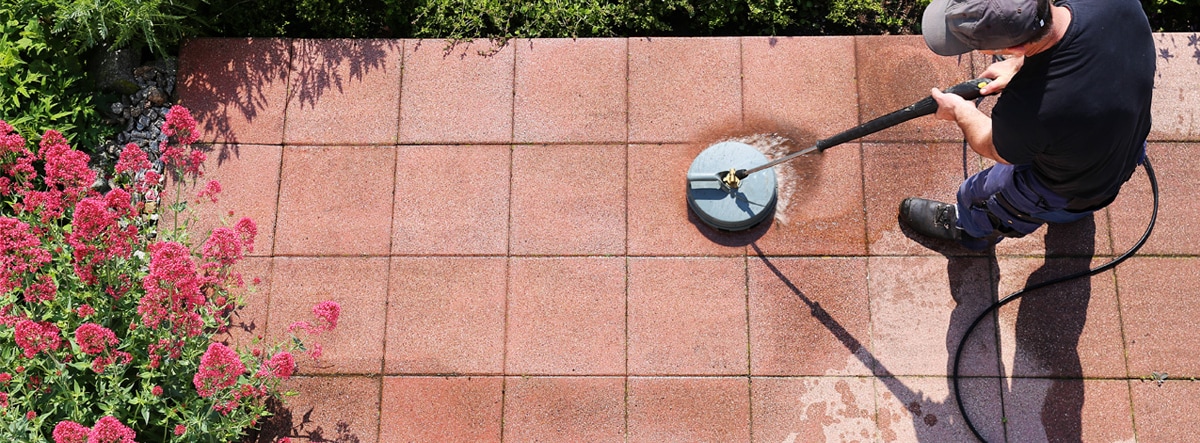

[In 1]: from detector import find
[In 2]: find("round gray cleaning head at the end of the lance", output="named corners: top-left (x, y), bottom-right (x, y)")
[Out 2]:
top-left (688, 142), bottom-right (775, 231)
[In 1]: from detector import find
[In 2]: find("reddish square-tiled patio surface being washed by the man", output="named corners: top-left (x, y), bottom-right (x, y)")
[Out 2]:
top-left (179, 34), bottom-right (1200, 442)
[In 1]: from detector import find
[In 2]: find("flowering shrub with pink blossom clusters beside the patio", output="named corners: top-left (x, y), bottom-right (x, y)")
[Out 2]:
top-left (0, 107), bottom-right (340, 442)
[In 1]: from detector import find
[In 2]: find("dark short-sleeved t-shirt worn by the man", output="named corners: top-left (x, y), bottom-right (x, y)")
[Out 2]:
top-left (992, 0), bottom-right (1156, 210)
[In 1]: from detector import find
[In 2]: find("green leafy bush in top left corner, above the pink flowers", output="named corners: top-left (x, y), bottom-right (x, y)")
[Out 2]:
top-left (0, 4), bottom-right (115, 153)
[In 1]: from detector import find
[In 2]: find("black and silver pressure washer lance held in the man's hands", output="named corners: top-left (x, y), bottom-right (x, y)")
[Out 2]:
top-left (688, 78), bottom-right (991, 190)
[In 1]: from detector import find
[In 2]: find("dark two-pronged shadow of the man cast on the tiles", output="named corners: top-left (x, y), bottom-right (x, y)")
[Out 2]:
top-left (946, 217), bottom-right (1096, 442)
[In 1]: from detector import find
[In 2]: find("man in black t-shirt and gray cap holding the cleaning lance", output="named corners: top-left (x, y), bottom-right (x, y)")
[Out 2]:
top-left (900, 0), bottom-right (1156, 250)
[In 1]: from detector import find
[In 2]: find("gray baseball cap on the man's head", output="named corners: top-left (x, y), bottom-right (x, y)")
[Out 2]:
top-left (920, 0), bottom-right (1045, 55)
